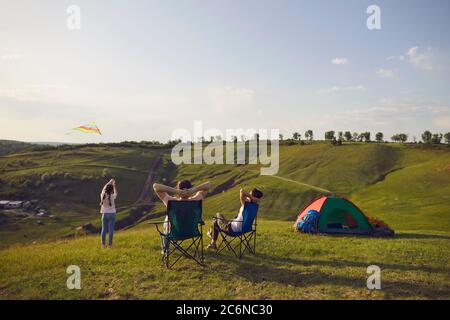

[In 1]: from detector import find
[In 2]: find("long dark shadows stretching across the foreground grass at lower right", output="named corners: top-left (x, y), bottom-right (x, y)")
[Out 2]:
top-left (208, 254), bottom-right (450, 299)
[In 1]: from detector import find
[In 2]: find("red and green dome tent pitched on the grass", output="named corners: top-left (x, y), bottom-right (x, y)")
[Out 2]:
top-left (295, 196), bottom-right (373, 235)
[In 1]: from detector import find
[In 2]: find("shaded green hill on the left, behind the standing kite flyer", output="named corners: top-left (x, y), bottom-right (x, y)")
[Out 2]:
top-left (0, 146), bottom-right (164, 246)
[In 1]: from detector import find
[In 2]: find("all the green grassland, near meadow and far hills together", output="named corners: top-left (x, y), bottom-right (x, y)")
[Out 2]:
top-left (0, 143), bottom-right (450, 299)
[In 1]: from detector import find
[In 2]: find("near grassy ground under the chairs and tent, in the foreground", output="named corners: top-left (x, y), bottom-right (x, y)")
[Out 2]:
top-left (0, 220), bottom-right (450, 300)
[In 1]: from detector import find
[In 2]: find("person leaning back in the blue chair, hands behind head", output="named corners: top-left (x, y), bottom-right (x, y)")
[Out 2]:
top-left (207, 188), bottom-right (263, 249)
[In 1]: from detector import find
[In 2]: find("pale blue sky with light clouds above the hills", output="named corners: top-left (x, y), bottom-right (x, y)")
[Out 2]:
top-left (0, 0), bottom-right (450, 142)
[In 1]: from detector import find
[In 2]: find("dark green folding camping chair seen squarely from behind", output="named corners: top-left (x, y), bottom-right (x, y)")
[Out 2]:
top-left (150, 200), bottom-right (205, 268)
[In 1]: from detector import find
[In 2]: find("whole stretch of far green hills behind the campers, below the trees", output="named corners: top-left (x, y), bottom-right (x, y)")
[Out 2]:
top-left (0, 143), bottom-right (450, 246)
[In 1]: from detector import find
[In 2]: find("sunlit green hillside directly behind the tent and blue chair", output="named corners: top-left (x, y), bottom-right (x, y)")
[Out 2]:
top-left (174, 143), bottom-right (450, 231)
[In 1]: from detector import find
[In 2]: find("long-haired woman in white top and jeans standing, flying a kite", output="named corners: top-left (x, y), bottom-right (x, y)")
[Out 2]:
top-left (100, 179), bottom-right (117, 248)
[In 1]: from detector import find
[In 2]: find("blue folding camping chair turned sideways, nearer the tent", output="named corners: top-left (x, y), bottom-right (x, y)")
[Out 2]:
top-left (215, 202), bottom-right (259, 259)
